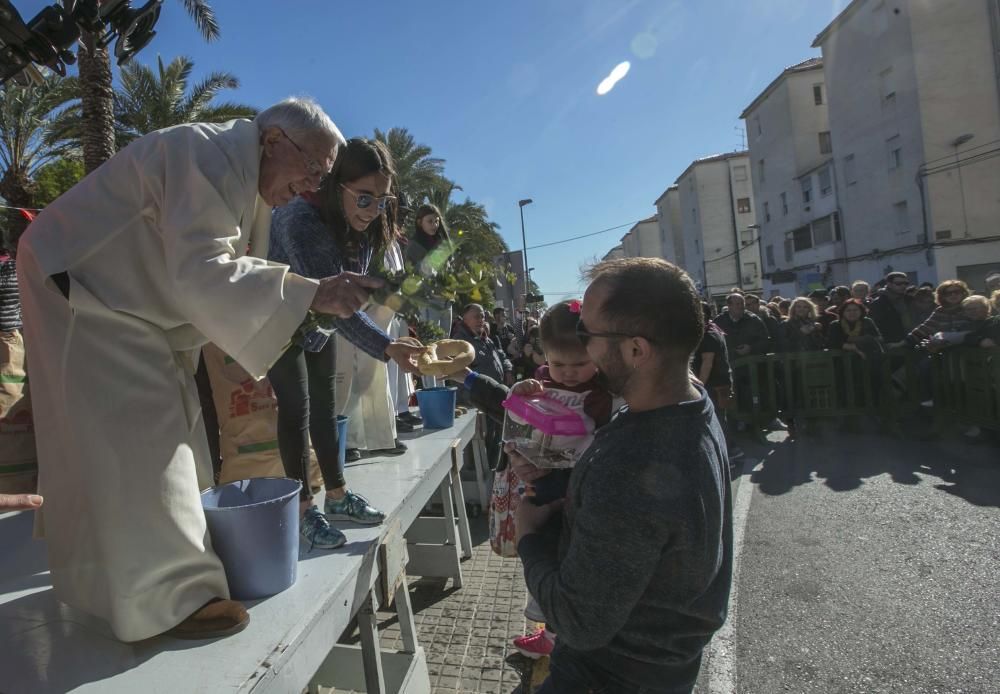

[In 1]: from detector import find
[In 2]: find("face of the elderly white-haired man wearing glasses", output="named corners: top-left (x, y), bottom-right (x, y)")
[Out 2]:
top-left (257, 126), bottom-right (337, 207)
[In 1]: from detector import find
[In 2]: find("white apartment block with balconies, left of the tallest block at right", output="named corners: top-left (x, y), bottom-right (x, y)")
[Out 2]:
top-left (740, 58), bottom-right (849, 297)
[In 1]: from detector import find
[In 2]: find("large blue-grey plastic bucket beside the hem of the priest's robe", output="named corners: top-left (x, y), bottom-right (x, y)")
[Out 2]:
top-left (201, 477), bottom-right (302, 600)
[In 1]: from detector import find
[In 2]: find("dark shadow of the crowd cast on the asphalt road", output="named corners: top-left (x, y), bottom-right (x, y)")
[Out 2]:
top-left (734, 424), bottom-right (1000, 507)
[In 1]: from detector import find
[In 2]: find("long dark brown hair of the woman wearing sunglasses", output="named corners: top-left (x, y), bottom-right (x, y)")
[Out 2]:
top-left (314, 137), bottom-right (396, 265)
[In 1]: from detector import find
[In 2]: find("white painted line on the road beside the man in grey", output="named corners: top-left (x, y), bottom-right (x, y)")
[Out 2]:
top-left (706, 450), bottom-right (760, 694)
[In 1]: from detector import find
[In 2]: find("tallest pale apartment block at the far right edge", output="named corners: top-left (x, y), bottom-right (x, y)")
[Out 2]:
top-left (812, 0), bottom-right (1000, 289)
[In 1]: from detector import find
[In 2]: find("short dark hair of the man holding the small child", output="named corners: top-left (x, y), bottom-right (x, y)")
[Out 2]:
top-left (587, 258), bottom-right (705, 362)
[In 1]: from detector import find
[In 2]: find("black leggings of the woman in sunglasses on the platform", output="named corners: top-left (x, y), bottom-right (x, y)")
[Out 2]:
top-left (267, 340), bottom-right (346, 499)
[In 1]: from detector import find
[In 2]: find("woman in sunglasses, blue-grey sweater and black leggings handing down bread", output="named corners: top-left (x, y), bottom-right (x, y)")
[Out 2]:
top-left (268, 138), bottom-right (419, 549)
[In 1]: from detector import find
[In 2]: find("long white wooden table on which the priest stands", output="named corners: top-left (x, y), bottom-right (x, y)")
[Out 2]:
top-left (0, 413), bottom-right (475, 694)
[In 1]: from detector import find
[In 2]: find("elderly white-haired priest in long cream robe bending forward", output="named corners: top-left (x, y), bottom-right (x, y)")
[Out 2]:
top-left (18, 99), bottom-right (408, 641)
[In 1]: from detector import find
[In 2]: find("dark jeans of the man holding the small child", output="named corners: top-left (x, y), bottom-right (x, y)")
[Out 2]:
top-left (535, 641), bottom-right (697, 694)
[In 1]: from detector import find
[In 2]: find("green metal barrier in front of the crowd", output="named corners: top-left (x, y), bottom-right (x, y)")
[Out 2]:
top-left (729, 348), bottom-right (1000, 432)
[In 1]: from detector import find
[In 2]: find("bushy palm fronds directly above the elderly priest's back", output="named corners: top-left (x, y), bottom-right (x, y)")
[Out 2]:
top-left (114, 56), bottom-right (257, 147)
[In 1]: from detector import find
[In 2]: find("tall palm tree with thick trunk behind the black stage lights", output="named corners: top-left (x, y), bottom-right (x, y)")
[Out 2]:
top-left (73, 0), bottom-right (220, 173)
